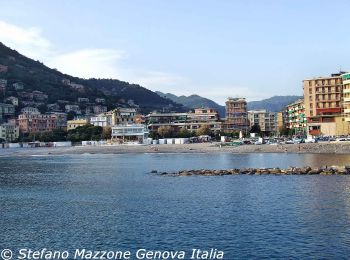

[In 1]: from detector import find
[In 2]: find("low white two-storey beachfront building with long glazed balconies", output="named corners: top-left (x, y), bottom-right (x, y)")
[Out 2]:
top-left (112, 124), bottom-right (148, 144)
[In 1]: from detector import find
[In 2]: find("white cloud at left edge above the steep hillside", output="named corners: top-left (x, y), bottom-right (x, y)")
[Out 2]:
top-left (0, 21), bottom-right (52, 60)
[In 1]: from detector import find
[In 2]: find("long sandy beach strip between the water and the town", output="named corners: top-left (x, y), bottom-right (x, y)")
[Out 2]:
top-left (0, 142), bottom-right (350, 156)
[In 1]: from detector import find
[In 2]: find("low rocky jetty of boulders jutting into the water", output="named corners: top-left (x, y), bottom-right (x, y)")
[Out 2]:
top-left (152, 166), bottom-right (350, 176)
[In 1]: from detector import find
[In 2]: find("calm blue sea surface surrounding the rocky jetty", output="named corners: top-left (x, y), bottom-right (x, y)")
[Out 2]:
top-left (0, 154), bottom-right (350, 259)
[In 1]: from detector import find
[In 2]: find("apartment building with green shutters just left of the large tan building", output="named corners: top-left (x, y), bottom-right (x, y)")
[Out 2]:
top-left (286, 99), bottom-right (307, 135)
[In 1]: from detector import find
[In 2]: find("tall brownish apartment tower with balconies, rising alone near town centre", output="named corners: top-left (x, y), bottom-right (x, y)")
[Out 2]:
top-left (223, 98), bottom-right (249, 133)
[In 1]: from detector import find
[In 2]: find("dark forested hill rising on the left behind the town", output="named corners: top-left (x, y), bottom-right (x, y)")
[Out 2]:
top-left (0, 43), bottom-right (187, 113)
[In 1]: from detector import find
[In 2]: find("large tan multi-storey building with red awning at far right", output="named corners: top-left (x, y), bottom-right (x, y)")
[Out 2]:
top-left (303, 72), bottom-right (349, 135)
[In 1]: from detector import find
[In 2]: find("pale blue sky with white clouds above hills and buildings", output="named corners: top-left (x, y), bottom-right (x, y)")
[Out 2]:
top-left (0, 0), bottom-right (350, 104)
